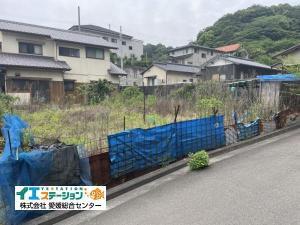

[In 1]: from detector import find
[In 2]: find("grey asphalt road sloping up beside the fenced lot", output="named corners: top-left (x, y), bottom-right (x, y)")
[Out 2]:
top-left (60, 130), bottom-right (300, 225)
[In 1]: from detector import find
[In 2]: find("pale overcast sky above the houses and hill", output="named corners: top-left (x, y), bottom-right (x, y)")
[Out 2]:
top-left (0, 0), bottom-right (300, 47)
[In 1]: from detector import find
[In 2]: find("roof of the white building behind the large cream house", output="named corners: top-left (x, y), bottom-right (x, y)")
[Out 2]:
top-left (69, 25), bottom-right (132, 39)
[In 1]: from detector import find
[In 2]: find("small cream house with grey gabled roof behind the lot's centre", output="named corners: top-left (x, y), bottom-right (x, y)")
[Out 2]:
top-left (142, 63), bottom-right (200, 86)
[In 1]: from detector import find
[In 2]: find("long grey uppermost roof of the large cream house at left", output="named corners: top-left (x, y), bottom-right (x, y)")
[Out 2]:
top-left (0, 20), bottom-right (116, 48)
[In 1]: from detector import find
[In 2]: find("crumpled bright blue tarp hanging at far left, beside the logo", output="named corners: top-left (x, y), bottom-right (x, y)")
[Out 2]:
top-left (0, 115), bottom-right (53, 224)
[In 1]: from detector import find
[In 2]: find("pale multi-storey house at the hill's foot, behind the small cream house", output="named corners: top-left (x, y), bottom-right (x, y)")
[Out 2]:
top-left (169, 43), bottom-right (221, 66)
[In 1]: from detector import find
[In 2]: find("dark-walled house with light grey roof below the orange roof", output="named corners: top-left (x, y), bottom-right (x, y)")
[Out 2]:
top-left (198, 55), bottom-right (279, 81)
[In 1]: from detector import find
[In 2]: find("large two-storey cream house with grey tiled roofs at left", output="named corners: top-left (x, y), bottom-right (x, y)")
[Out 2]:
top-left (0, 20), bottom-right (126, 103)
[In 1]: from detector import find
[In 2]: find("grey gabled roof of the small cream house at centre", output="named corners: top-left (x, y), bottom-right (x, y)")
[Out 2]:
top-left (143, 63), bottom-right (200, 74)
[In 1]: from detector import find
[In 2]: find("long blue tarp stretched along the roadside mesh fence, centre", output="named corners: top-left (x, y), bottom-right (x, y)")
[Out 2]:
top-left (108, 116), bottom-right (225, 177)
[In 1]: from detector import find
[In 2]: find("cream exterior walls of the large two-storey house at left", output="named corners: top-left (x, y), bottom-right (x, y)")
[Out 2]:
top-left (0, 32), bottom-right (119, 83)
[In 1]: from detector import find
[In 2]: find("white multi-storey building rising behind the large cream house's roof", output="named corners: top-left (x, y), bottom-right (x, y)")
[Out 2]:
top-left (70, 25), bottom-right (143, 60)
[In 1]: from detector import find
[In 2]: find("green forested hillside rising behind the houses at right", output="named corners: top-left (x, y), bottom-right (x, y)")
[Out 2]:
top-left (197, 4), bottom-right (300, 64)
